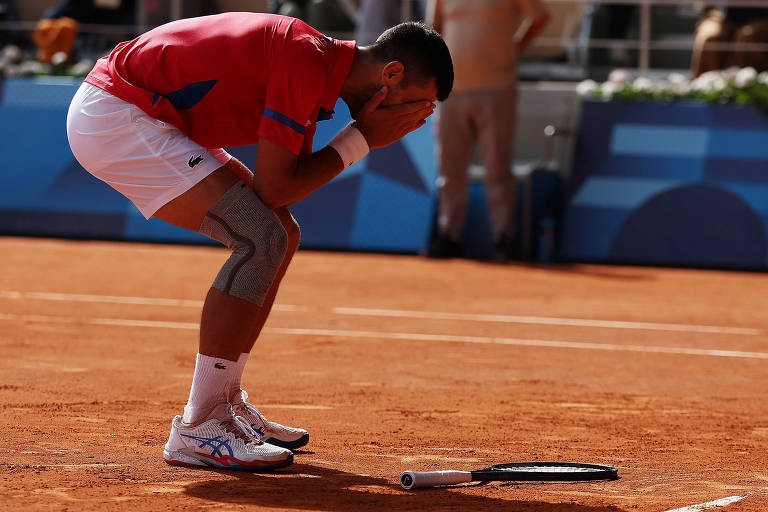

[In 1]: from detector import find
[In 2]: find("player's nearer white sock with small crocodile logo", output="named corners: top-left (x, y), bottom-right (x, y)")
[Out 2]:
top-left (183, 354), bottom-right (237, 425)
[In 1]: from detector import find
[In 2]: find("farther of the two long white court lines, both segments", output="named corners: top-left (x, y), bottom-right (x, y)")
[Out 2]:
top-left (0, 290), bottom-right (761, 335)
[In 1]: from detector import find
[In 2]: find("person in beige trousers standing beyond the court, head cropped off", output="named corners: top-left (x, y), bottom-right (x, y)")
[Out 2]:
top-left (426, 0), bottom-right (549, 261)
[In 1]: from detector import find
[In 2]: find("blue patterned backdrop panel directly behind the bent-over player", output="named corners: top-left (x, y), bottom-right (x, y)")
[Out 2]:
top-left (0, 78), bottom-right (437, 253)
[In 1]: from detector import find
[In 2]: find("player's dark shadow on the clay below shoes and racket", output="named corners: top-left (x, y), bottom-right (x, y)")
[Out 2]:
top-left (184, 464), bottom-right (623, 512)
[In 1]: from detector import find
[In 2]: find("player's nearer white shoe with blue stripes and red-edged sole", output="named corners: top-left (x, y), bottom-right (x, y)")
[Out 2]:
top-left (163, 402), bottom-right (293, 471)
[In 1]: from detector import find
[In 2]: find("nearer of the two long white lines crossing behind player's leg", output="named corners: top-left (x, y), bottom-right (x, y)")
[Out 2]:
top-left (6, 315), bottom-right (768, 359)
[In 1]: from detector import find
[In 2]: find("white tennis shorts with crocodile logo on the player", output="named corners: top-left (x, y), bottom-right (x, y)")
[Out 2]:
top-left (67, 82), bottom-right (232, 219)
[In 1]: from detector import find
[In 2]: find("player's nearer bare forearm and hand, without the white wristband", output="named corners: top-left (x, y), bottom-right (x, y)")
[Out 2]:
top-left (253, 87), bottom-right (435, 209)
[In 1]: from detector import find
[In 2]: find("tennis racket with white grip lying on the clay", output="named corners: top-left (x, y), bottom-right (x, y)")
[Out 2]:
top-left (400, 462), bottom-right (619, 490)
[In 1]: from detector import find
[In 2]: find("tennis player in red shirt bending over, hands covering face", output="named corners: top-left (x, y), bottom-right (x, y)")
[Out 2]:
top-left (67, 13), bottom-right (453, 471)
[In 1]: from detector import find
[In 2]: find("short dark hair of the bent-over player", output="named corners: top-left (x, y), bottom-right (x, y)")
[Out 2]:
top-left (371, 21), bottom-right (453, 101)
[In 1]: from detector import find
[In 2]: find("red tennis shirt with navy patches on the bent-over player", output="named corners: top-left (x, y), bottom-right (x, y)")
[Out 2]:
top-left (85, 12), bottom-right (355, 154)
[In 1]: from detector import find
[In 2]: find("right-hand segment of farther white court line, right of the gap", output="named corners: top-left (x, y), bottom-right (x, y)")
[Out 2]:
top-left (333, 308), bottom-right (760, 335)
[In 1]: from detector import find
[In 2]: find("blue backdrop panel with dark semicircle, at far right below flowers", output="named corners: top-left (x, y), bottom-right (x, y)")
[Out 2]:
top-left (560, 100), bottom-right (768, 269)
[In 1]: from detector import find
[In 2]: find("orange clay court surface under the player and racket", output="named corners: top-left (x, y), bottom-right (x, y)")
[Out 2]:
top-left (0, 238), bottom-right (768, 512)
